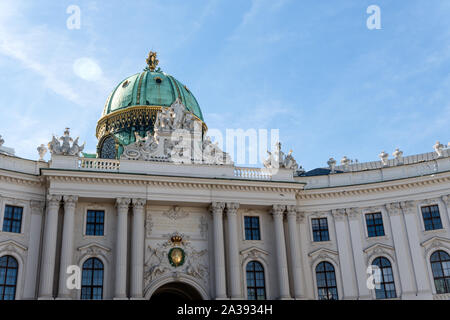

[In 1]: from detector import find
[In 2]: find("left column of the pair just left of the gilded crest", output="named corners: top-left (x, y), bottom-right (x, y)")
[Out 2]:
top-left (114, 198), bottom-right (131, 300)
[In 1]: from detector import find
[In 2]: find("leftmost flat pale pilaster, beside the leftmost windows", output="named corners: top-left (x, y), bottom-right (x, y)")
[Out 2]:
top-left (23, 200), bottom-right (44, 300)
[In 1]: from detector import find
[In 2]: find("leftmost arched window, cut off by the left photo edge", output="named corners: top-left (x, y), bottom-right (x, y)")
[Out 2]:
top-left (0, 256), bottom-right (19, 300)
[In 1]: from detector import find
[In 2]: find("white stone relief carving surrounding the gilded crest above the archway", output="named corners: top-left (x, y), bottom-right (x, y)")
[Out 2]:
top-left (144, 232), bottom-right (209, 284)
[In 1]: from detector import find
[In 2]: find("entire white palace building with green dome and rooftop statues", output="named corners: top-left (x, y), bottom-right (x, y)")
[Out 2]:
top-left (0, 53), bottom-right (450, 300)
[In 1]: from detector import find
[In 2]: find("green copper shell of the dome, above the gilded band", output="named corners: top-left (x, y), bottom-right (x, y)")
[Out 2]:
top-left (102, 71), bottom-right (203, 121)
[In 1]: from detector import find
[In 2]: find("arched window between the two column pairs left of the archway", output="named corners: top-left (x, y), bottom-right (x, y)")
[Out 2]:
top-left (81, 258), bottom-right (103, 300)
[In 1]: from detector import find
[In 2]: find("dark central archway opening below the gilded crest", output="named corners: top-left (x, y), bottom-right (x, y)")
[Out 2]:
top-left (150, 282), bottom-right (203, 301)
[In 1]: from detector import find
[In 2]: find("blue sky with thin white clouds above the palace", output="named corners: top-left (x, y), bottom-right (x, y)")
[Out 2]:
top-left (0, 0), bottom-right (450, 169)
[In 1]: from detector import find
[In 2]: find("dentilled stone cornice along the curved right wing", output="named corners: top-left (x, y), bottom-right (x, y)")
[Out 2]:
top-left (297, 173), bottom-right (450, 200)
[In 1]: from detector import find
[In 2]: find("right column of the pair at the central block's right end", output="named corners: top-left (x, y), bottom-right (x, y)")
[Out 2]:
top-left (286, 206), bottom-right (304, 299)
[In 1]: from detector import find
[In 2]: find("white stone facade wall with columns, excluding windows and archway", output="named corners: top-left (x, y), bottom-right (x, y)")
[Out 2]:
top-left (0, 142), bottom-right (450, 299)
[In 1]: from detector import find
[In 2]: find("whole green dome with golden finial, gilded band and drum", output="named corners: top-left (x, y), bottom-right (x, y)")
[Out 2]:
top-left (96, 51), bottom-right (207, 159)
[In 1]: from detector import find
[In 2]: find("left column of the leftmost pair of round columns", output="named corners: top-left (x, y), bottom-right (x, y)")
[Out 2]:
top-left (39, 195), bottom-right (61, 300)
